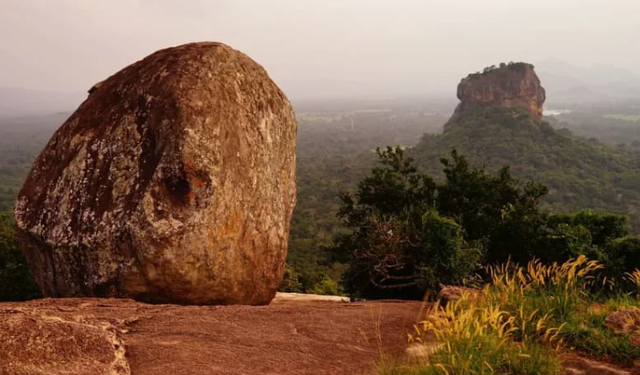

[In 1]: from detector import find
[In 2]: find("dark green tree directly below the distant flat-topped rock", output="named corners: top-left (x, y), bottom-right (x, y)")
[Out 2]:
top-left (437, 149), bottom-right (547, 262)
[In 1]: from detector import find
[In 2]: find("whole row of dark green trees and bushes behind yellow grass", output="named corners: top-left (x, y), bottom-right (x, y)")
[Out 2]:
top-left (333, 144), bottom-right (640, 298)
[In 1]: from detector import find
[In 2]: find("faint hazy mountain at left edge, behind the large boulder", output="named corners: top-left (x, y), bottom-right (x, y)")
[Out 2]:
top-left (0, 87), bottom-right (87, 117)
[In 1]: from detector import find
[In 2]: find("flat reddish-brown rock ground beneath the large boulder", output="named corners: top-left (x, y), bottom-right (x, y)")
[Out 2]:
top-left (0, 299), bottom-right (422, 375)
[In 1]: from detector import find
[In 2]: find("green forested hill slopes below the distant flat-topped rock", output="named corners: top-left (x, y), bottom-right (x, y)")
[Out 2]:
top-left (411, 62), bottom-right (640, 232)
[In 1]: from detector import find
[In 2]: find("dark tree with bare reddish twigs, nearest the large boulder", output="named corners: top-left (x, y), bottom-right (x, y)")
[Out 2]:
top-left (332, 147), bottom-right (480, 298)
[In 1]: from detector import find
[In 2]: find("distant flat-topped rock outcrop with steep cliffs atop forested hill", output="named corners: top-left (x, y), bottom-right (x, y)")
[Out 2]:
top-left (445, 63), bottom-right (546, 131)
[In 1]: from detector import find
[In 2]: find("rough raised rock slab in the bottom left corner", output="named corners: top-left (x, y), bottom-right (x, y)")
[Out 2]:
top-left (0, 308), bottom-right (131, 375)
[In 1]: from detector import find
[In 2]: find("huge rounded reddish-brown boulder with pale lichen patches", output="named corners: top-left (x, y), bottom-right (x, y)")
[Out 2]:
top-left (15, 43), bottom-right (297, 304)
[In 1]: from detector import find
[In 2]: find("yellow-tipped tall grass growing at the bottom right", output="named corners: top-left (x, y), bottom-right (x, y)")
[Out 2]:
top-left (379, 256), bottom-right (640, 375)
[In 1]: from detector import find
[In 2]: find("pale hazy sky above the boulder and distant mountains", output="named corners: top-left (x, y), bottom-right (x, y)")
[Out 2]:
top-left (0, 0), bottom-right (640, 99)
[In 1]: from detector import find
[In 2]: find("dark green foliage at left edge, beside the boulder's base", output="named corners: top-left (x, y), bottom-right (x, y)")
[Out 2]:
top-left (0, 212), bottom-right (40, 301)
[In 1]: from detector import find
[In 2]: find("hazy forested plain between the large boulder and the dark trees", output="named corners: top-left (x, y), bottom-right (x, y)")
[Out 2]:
top-left (281, 109), bottom-right (445, 292)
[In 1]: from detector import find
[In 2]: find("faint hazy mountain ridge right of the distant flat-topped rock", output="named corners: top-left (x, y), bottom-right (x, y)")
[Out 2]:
top-left (536, 59), bottom-right (640, 103)
